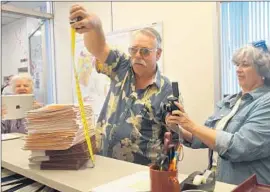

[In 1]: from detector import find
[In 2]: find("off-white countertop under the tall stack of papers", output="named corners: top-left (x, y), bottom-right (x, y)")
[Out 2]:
top-left (2, 135), bottom-right (235, 192)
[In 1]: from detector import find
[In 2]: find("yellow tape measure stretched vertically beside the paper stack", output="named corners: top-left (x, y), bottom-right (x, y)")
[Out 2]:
top-left (71, 28), bottom-right (95, 165)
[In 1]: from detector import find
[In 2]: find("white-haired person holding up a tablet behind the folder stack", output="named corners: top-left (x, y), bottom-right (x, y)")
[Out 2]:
top-left (1, 74), bottom-right (42, 133)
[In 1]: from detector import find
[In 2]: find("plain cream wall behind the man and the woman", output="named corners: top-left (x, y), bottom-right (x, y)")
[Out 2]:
top-left (55, 2), bottom-right (219, 173)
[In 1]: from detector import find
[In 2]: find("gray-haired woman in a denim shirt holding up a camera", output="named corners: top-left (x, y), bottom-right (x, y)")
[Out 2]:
top-left (166, 41), bottom-right (270, 184)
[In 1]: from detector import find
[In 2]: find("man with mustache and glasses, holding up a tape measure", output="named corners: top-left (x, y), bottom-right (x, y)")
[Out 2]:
top-left (70, 5), bottom-right (178, 165)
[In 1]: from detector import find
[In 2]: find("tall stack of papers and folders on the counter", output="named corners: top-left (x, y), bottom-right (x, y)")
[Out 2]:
top-left (24, 104), bottom-right (96, 170)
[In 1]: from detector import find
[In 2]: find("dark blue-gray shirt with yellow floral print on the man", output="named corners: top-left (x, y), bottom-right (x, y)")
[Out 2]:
top-left (96, 50), bottom-right (178, 165)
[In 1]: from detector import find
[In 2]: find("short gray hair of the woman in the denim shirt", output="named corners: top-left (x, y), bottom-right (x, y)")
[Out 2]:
top-left (232, 45), bottom-right (270, 85)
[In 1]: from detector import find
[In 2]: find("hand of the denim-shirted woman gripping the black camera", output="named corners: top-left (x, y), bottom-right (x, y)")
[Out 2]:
top-left (166, 102), bottom-right (196, 133)
